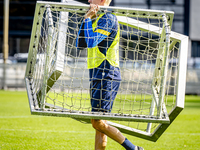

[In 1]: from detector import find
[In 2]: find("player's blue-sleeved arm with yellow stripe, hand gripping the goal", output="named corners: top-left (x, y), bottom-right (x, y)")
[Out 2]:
top-left (76, 4), bottom-right (116, 48)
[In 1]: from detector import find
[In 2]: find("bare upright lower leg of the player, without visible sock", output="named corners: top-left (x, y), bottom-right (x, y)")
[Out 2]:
top-left (95, 130), bottom-right (107, 150)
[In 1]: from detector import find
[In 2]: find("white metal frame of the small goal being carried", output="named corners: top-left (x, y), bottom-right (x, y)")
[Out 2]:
top-left (25, 1), bottom-right (188, 141)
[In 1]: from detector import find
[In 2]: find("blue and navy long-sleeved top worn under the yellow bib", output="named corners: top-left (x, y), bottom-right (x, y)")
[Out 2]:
top-left (76, 13), bottom-right (121, 81)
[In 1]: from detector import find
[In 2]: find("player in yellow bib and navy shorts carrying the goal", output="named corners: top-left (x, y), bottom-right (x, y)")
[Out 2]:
top-left (76, 0), bottom-right (143, 150)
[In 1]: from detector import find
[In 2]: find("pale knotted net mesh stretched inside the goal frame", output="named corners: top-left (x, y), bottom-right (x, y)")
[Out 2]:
top-left (25, 6), bottom-right (179, 130)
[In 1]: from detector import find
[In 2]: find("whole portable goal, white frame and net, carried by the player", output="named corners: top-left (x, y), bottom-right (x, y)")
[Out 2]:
top-left (25, 2), bottom-right (188, 141)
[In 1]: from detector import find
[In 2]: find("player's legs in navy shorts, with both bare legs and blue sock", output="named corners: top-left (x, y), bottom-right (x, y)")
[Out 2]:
top-left (91, 80), bottom-right (141, 150)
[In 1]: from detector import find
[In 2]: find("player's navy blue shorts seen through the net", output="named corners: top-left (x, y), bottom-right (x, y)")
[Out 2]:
top-left (90, 80), bottom-right (120, 112)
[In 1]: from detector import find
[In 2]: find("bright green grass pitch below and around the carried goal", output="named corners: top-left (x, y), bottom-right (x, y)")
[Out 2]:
top-left (0, 91), bottom-right (200, 150)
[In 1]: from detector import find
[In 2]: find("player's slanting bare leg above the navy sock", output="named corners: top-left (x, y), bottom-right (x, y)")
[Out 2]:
top-left (91, 119), bottom-right (125, 144)
